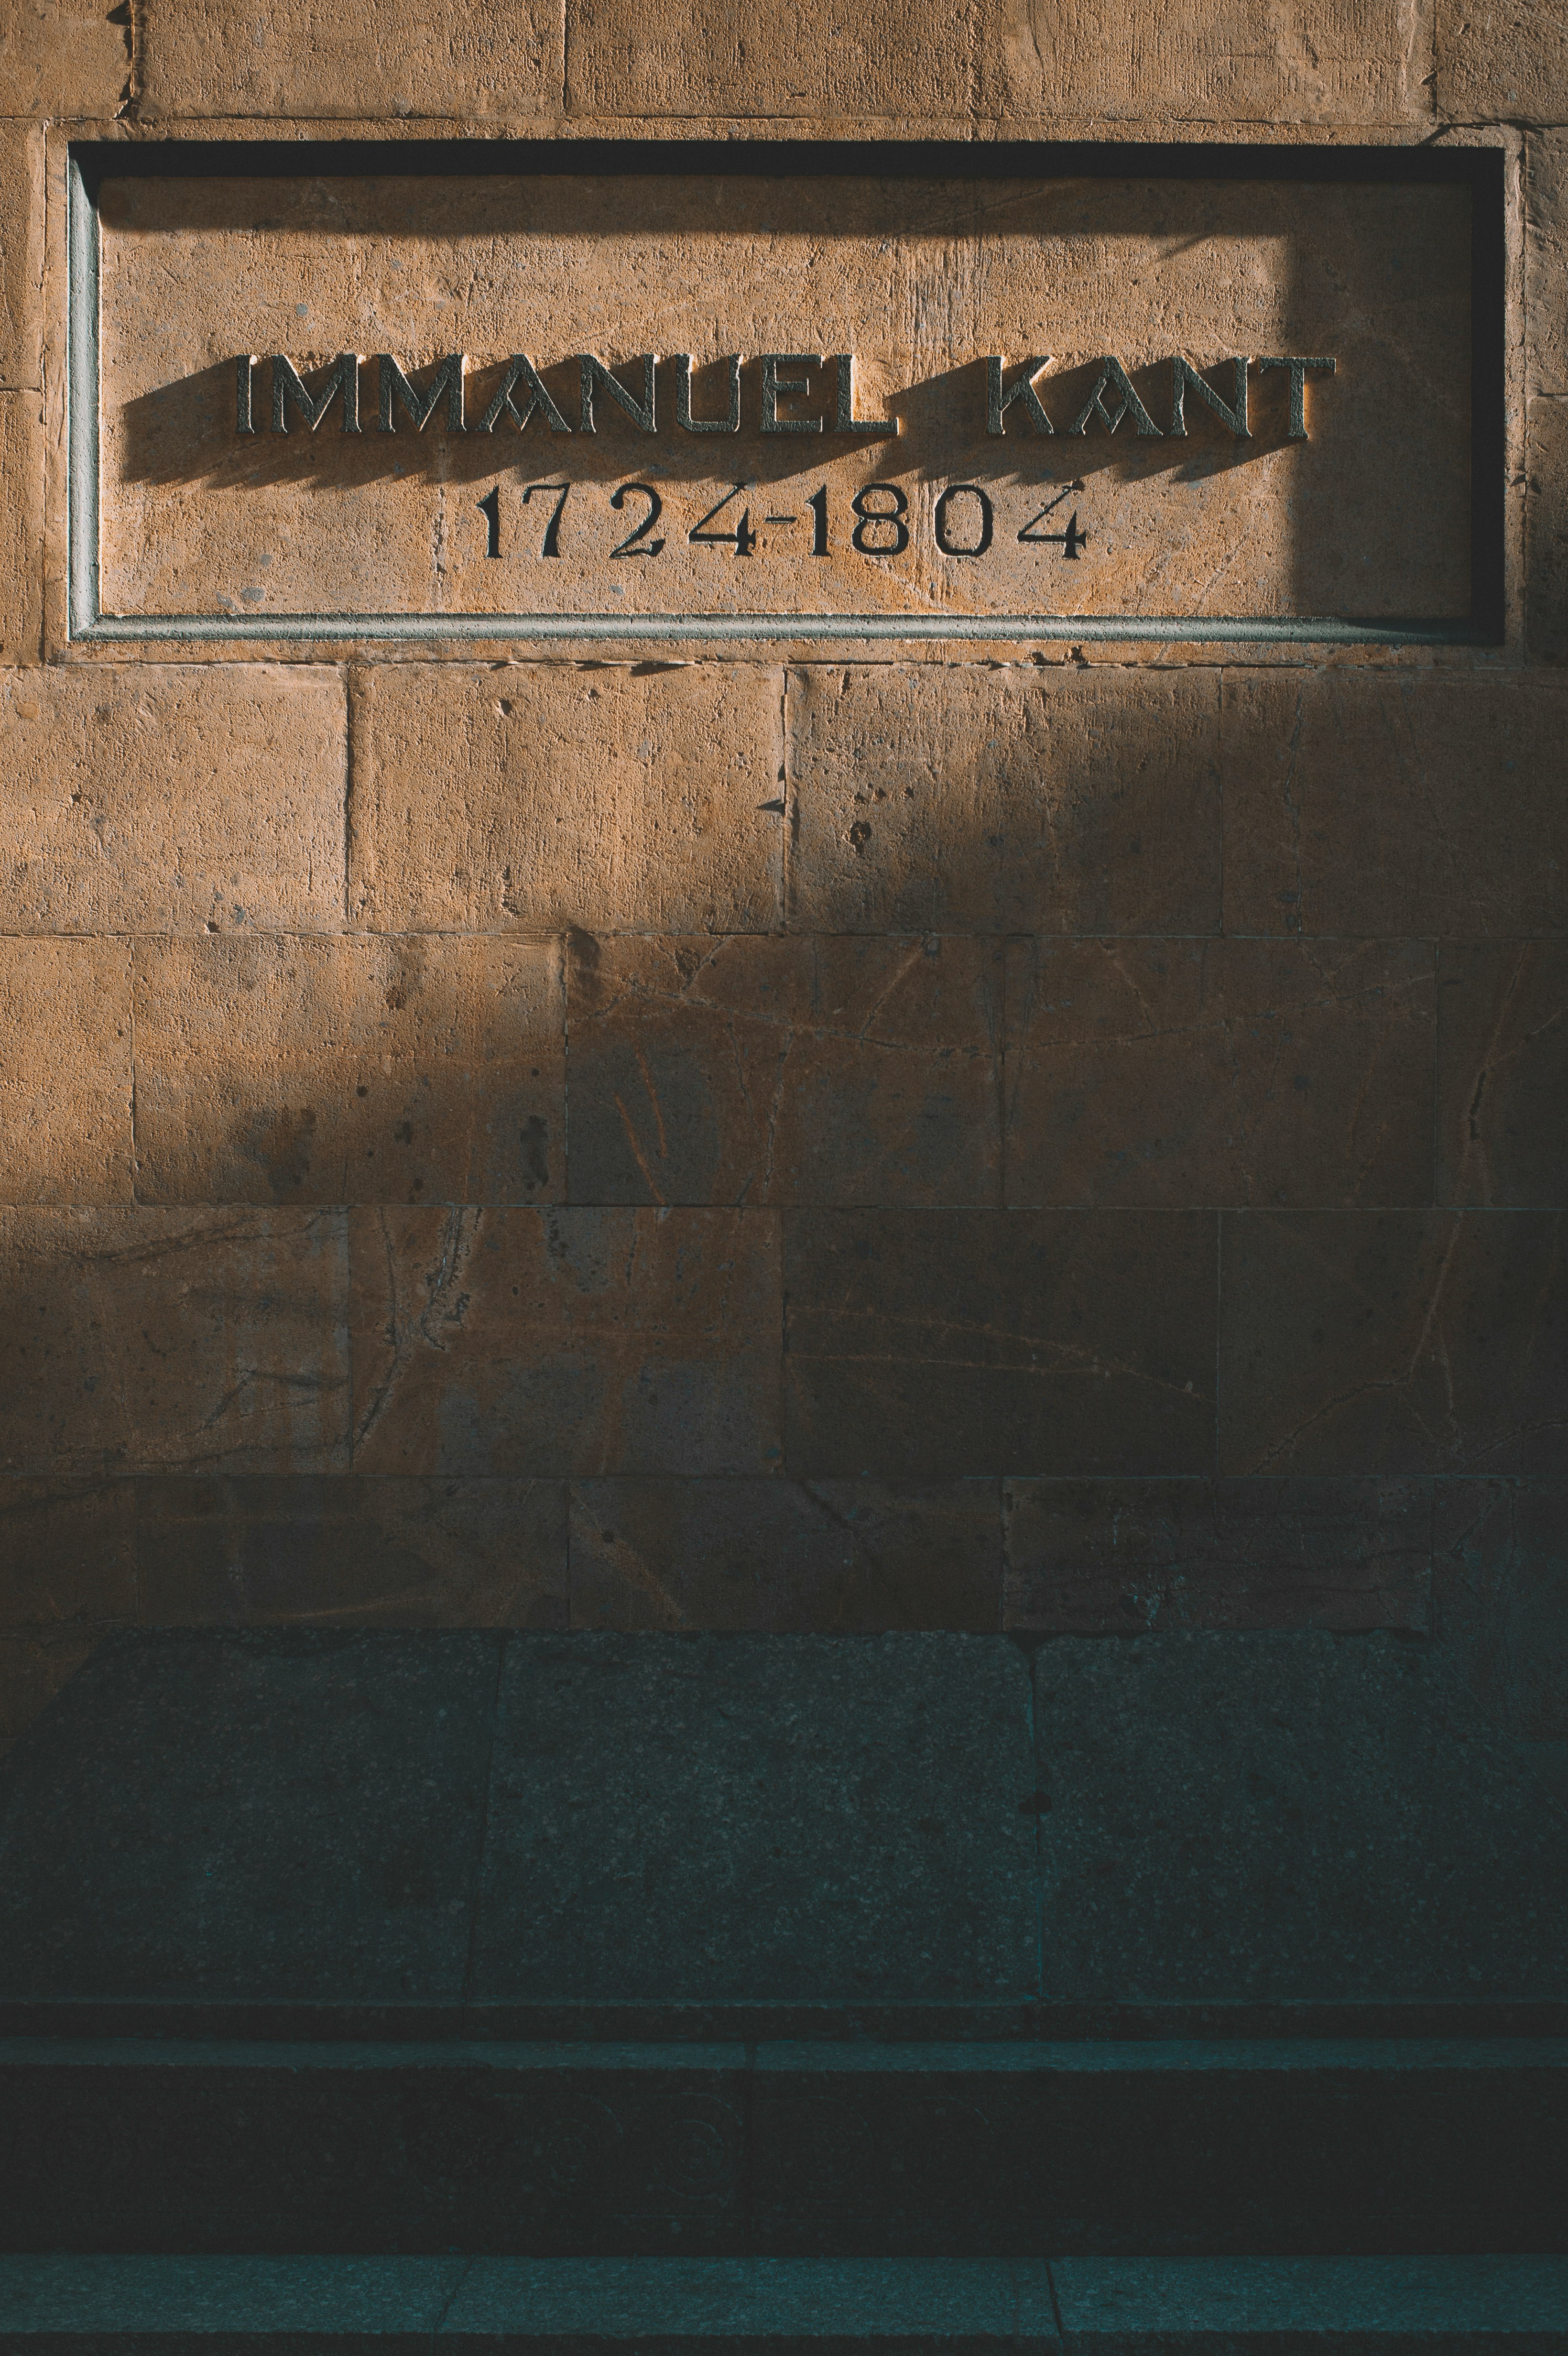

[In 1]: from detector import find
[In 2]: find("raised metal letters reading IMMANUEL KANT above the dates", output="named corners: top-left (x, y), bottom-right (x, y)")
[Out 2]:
top-left (235, 351), bottom-right (1337, 441)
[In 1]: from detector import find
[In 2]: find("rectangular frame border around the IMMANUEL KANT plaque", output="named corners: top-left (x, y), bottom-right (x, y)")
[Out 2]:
top-left (66, 137), bottom-right (1507, 648)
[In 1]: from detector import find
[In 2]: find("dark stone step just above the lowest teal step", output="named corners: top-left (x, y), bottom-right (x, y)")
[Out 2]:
top-left (0, 2038), bottom-right (1568, 2259)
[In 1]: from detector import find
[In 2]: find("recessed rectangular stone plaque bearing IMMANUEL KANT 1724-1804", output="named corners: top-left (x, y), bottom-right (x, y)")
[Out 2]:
top-left (71, 148), bottom-right (1500, 641)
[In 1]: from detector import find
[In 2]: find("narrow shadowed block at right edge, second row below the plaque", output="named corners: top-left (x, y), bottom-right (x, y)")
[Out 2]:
top-left (1438, 940), bottom-right (1568, 1206)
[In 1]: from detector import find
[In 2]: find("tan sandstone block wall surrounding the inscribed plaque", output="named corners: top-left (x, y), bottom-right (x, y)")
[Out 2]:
top-left (0, 0), bottom-right (1568, 1741)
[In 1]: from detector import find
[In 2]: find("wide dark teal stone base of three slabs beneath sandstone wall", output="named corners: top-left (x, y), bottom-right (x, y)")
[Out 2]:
top-left (0, 1630), bottom-right (1568, 2036)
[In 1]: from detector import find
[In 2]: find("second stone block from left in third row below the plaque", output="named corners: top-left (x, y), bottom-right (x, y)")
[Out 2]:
top-left (348, 1209), bottom-right (779, 1475)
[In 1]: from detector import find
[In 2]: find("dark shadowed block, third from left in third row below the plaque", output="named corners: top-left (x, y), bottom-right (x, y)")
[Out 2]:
top-left (784, 1211), bottom-right (1215, 1477)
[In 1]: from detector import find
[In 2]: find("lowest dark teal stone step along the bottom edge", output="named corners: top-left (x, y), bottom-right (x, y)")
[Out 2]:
top-left (0, 2257), bottom-right (1568, 2356)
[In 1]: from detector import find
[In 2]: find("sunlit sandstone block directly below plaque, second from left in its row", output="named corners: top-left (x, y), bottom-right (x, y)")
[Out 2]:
top-left (351, 665), bottom-right (784, 933)
